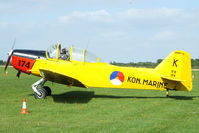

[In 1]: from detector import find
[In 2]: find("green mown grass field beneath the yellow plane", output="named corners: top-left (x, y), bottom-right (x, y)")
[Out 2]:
top-left (0, 68), bottom-right (199, 133)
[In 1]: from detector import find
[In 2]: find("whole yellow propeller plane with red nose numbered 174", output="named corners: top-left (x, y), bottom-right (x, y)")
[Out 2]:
top-left (5, 43), bottom-right (192, 99)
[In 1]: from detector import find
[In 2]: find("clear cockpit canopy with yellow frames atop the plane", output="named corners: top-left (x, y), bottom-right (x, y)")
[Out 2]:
top-left (46, 44), bottom-right (101, 63)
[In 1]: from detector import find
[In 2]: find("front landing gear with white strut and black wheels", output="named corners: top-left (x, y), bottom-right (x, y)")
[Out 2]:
top-left (32, 78), bottom-right (51, 99)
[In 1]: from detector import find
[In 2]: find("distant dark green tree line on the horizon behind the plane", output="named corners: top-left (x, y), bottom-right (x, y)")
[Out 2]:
top-left (0, 59), bottom-right (199, 69)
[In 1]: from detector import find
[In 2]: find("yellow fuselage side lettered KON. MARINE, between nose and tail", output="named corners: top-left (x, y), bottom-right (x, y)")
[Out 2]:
top-left (31, 59), bottom-right (168, 90)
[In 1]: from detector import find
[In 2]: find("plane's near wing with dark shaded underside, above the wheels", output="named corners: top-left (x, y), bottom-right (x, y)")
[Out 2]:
top-left (39, 69), bottom-right (87, 88)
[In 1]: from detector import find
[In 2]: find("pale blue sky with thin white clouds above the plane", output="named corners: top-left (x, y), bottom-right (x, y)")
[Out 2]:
top-left (0, 0), bottom-right (199, 62)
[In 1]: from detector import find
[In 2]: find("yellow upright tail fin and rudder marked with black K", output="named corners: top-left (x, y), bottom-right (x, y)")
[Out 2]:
top-left (155, 50), bottom-right (192, 91)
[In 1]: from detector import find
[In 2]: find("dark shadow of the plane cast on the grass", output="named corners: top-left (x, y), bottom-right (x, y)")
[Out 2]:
top-left (52, 91), bottom-right (196, 103)
